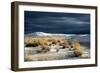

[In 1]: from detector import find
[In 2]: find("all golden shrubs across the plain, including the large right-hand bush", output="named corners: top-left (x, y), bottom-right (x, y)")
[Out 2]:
top-left (25, 37), bottom-right (82, 56)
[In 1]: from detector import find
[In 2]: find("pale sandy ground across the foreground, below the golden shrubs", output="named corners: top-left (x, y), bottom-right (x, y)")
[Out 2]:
top-left (24, 47), bottom-right (90, 61)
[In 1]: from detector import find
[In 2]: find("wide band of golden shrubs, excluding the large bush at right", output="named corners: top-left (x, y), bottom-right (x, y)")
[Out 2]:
top-left (25, 37), bottom-right (68, 53)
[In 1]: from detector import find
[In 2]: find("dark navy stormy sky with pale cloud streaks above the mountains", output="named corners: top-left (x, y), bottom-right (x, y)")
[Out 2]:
top-left (24, 11), bottom-right (90, 34)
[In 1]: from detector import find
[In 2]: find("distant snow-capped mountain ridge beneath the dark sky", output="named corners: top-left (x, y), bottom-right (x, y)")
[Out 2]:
top-left (25, 32), bottom-right (90, 42)
